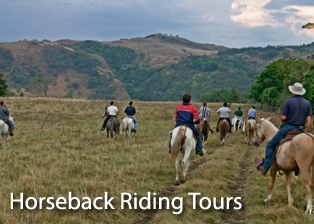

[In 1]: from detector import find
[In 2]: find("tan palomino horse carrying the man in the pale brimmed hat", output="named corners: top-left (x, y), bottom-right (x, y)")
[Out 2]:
top-left (253, 118), bottom-right (314, 214)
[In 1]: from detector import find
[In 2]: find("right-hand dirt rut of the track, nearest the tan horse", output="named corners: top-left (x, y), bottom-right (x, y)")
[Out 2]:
top-left (222, 147), bottom-right (252, 224)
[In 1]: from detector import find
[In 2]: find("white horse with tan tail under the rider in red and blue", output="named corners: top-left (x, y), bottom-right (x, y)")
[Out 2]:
top-left (170, 125), bottom-right (196, 185)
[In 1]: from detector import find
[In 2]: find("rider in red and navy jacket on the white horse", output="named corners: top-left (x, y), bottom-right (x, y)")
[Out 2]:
top-left (169, 93), bottom-right (204, 156)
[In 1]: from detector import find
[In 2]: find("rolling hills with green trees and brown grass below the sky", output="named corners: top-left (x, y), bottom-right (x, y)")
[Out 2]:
top-left (0, 34), bottom-right (314, 101)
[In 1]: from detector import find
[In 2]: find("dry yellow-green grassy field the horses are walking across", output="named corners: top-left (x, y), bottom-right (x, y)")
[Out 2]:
top-left (0, 97), bottom-right (314, 224)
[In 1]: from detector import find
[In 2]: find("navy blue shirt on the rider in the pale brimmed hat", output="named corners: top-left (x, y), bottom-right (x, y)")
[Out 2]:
top-left (281, 95), bottom-right (312, 126)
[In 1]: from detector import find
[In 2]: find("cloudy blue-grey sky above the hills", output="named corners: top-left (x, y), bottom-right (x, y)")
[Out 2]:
top-left (0, 0), bottom-right (314, 48)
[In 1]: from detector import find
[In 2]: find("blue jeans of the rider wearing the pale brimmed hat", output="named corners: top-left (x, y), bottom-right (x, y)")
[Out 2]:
top-left (263, 124), bottom-right (304, 171)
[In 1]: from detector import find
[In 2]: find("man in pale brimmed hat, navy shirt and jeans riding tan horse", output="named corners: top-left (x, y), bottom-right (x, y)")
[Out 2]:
top-left (255, 82), bottom-right (312, 175)
